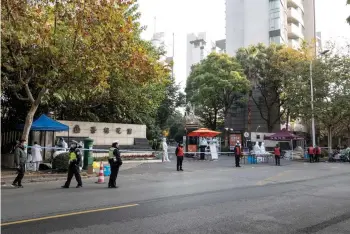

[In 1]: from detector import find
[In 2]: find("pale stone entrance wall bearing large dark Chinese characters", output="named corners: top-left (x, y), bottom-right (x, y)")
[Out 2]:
top-left (56, 120), bottom-right (146, 145)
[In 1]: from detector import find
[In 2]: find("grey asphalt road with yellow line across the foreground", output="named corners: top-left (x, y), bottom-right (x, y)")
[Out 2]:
top-left (1, 158), bottom-right (350, 234)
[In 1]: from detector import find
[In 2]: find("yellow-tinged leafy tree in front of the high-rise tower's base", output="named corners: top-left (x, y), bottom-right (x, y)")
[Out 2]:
top-left (236, 44), bottom-right (305, 132)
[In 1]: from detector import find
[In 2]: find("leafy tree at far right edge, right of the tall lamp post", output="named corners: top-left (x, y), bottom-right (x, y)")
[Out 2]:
top-left (314, 50), bottom-right (350, 150)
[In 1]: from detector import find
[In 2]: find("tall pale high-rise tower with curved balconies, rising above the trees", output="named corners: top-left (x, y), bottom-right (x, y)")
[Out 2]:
top-left (226, 0), bottom-right (316, 55)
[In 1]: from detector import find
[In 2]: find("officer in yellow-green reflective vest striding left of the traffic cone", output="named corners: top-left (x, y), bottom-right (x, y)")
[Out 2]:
top-left (62, 142), bottom-right (83, 188)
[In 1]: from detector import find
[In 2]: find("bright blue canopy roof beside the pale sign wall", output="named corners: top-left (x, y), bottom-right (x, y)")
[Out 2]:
top-left (18, 114), bottom-right (69, 132)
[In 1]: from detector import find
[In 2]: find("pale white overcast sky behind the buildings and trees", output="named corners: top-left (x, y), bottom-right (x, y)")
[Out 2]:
top-left (138, 0), bottom-right (350, 87)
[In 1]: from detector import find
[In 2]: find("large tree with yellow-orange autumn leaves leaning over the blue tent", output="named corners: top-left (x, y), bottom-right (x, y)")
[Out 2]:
top-left (1, 0), bottom-right (168, 139)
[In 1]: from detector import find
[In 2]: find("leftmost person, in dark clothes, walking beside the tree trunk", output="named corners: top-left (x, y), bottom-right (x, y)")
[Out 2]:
top-left (12, 140), bottom-right (27, 188)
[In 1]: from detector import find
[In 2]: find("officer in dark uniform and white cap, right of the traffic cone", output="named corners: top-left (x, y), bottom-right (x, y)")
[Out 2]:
top-left (108, 141), bottom-right (123, 188)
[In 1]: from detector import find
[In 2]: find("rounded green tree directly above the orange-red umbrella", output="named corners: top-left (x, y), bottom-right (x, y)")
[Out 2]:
top-left (186, 53), bottom-right (250, 129)
